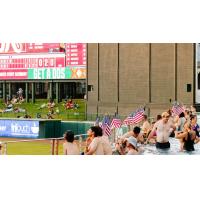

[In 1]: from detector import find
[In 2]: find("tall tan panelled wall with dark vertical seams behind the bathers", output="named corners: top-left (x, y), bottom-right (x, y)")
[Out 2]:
top-left (87, 43), bottom-right (195, 117)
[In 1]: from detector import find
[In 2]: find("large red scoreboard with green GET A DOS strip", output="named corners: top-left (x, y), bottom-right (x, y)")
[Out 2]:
top-left (0, 43), bottom-right (87, 80)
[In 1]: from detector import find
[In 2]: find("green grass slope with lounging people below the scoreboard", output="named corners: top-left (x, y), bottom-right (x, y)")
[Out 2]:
top-left (0, 99), bottom-right (85, 121)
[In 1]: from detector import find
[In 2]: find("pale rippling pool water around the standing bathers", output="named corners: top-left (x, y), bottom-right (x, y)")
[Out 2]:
top-left (141, 138), bottom-right (200, 155)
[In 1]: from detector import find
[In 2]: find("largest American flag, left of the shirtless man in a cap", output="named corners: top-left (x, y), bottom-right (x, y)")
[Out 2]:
top-left (123, 108), bottom-right (144, 125)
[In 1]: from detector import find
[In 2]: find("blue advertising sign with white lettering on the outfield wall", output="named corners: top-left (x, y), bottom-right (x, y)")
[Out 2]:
top-left (0, 120), bottom-right (39, 138)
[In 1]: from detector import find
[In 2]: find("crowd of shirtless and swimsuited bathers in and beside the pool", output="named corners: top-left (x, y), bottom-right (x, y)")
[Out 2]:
top-left (63, 106), bottom-right (200, 155)
